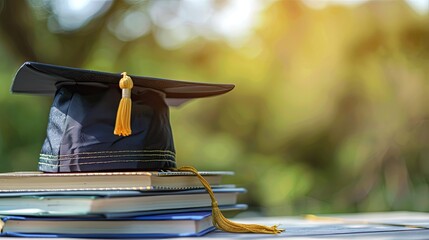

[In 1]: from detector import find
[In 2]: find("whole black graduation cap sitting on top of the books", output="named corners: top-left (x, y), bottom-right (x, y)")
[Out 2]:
top-left (12, 62), bottom-right (234, 172)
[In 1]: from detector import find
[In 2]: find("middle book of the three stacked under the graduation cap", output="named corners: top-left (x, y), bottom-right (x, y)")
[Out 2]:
top-left (0, 188), bottom-right (245, 216)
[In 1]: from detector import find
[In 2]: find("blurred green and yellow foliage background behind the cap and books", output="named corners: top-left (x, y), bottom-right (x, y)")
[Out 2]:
top-left (0, 0), bottom-right (429, 215)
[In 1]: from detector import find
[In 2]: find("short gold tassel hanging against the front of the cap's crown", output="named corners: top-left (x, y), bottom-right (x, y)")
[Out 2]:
top-left (113, 72), bottom-right (133, 136)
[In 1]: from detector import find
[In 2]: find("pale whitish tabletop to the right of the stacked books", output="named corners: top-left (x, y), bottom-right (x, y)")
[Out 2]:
top-left (2, 212), bottom-right (429, 240)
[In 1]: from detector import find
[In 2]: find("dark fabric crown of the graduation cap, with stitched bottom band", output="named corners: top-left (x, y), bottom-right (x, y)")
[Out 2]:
top-left (39, 86), bottom-right (176, 172)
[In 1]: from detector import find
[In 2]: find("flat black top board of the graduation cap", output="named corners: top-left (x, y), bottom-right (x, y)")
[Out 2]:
top-left (11, 62), bottom-right (234, 105)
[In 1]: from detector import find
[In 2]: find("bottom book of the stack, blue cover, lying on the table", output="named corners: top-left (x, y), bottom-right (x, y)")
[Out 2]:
top-left (0, 212), bottom-right (214, 238)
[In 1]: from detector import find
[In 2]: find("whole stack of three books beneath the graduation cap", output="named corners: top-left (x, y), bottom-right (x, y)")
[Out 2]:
top-left (0, 171), bottom-right (247, 238)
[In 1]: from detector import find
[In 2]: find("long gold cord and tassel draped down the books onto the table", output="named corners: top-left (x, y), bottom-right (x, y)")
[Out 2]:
top-left (178, 166), bottom-right (284, 234)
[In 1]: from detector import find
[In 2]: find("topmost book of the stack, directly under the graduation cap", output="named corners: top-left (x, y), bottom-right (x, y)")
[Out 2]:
top-left (0, 171), bottom-right (233, 192)
